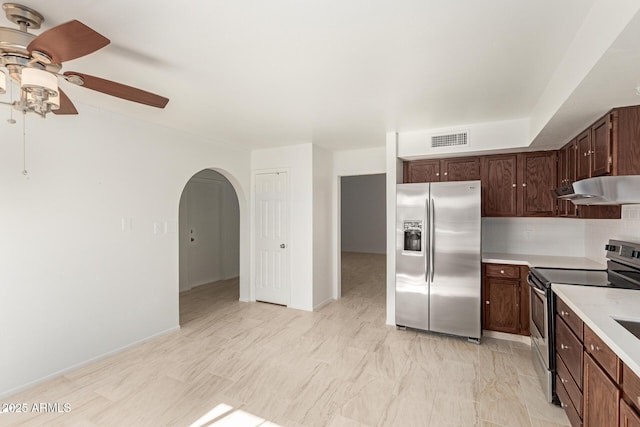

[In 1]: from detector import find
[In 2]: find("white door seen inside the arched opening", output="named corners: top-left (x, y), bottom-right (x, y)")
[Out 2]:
top-left (186, 180), bottom-right (224, 288)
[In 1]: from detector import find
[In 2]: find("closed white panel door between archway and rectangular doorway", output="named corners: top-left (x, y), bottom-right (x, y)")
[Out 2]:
top-left (255, 172), bottom-right (289, 305)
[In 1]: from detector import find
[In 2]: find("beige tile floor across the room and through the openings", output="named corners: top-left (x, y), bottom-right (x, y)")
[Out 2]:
top-left (0, 253), bottom-right (568, 427)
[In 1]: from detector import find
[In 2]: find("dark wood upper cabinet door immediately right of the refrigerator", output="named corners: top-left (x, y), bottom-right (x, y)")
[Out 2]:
top-left (480, 154), bottom-right (518, 216)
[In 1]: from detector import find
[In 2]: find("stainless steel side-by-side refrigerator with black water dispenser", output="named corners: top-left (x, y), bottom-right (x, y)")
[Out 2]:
top-left (396, 181), bottom-right (482, 342)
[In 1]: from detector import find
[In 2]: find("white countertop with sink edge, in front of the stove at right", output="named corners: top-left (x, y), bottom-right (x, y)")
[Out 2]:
top-left (551, 283), bottom-right (640, 377)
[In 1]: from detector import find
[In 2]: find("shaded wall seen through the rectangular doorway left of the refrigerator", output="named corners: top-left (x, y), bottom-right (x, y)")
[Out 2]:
top-left (340, 174), bottom-right (387, 254)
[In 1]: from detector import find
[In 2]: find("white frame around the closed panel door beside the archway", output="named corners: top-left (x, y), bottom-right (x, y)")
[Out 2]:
top-left (249, 168), bottom-right (293, 307)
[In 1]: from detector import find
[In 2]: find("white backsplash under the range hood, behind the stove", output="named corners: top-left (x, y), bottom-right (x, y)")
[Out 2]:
top-left (584, 205), bottom-right (640, 263)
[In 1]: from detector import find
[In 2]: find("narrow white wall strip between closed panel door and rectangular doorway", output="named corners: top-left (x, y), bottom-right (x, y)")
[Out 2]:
top-left (313, 145), bottom-right (334, 309)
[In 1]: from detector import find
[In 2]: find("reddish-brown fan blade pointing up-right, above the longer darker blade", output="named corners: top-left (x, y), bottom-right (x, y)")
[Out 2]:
top-left (27, 20), bottom-right (111, 64)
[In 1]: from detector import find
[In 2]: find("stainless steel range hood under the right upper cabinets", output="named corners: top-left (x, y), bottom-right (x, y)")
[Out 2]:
top-left (552, 175), bottom-right (640, 205)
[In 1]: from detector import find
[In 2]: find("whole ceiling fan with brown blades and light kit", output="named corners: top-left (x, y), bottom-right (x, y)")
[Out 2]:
top-left (0, 3), bottom-right (169, 117)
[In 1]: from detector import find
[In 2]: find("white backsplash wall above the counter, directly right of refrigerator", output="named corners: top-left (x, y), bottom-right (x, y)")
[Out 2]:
top-left (482, 218), bottom-right (585, 257)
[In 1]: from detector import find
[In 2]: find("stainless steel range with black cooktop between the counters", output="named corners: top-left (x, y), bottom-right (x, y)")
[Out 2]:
top-left (527, 240), bottom-right (640, 404)
